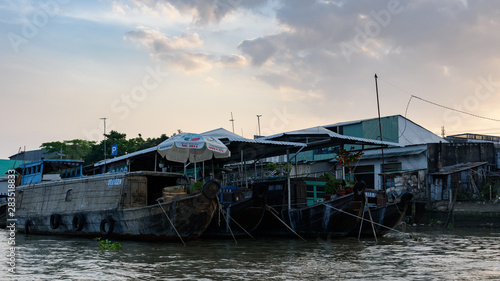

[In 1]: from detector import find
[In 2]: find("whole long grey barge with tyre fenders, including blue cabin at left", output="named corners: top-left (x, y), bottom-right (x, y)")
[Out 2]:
top-left (16, 160), bottom-right (220, 240)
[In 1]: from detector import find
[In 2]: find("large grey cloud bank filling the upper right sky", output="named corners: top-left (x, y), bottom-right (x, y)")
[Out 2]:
top-left (234, 0), bottom-right (500, 100)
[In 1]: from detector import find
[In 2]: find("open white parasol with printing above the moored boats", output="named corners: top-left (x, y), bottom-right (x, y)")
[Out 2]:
top-left (158, 133), bottom-right (231, 178)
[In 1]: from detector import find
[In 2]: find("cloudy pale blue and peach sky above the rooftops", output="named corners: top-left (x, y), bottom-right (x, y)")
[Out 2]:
top-left (0, 0), bottom-right (500, 156)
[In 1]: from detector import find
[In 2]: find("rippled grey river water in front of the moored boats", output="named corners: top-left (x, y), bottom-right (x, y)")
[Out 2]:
top-left (0, 229), bottom-right (500, 281)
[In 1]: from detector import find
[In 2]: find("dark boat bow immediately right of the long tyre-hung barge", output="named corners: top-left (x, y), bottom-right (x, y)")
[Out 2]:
top-left (203, 184), bottom-right (267, 238)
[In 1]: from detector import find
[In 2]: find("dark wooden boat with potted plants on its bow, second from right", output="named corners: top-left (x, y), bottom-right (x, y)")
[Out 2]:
top-left (254, 179), bottom-right (363, 237)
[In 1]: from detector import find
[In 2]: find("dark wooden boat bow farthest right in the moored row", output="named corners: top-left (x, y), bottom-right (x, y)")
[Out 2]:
top-left (350, 189), bottom-right (413, 237)
